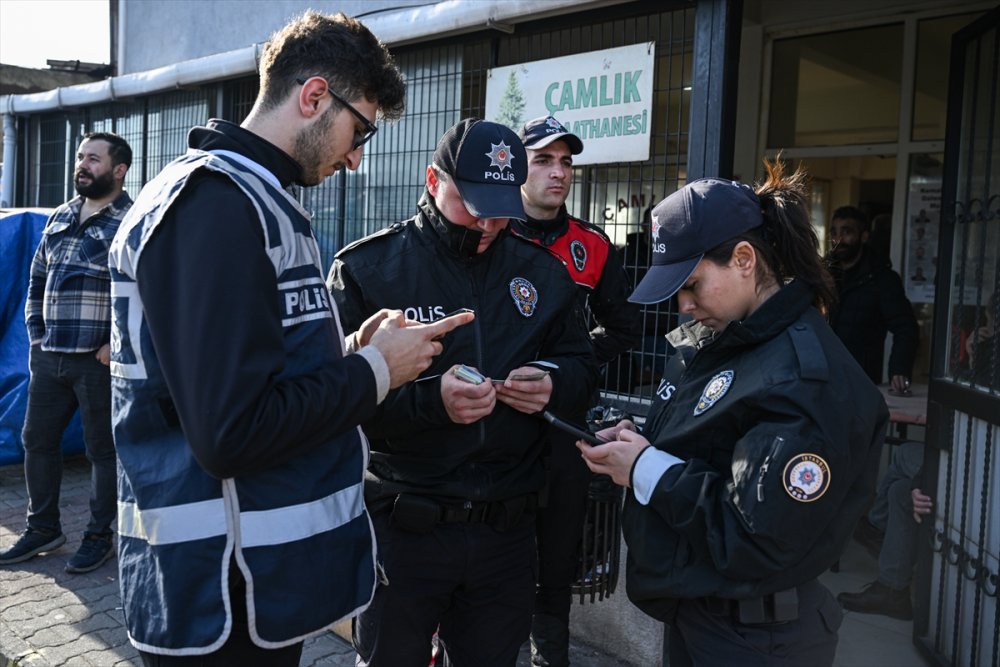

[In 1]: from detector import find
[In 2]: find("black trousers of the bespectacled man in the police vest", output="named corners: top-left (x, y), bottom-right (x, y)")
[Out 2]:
top-left (139, 563), bottom-right (303, 667)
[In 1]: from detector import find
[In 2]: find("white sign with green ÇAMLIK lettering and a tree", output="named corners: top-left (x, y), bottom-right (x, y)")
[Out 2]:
top-left (485, 42), bottom-right (656, 164)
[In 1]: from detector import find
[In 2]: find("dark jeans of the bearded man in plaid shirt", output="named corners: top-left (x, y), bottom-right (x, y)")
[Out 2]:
top-left (21, 345), bottom-right (118, 534)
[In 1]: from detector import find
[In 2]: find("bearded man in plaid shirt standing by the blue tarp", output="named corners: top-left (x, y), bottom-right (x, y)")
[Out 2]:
top-left (0, 132), bottom-right (132, 573)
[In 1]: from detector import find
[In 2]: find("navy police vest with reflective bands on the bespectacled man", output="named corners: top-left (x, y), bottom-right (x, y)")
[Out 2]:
top-left (110, 150), bottom-right (375, 655)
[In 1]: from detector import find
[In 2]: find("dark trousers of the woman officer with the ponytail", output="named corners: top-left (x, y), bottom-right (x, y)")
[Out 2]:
top-left (667, 581), bottom-right (843, 667)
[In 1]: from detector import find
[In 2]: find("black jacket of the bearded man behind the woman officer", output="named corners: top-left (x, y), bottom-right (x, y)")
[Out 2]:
top-left (830, 248), bottom-right (919, 384)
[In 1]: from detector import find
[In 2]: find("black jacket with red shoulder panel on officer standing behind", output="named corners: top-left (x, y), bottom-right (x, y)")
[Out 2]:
top-left (511, 206), bottom-right (642, 364)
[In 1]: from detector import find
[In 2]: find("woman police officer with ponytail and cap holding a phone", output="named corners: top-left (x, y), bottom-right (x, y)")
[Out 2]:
top-left (577, 163), bottom-right (888, 667)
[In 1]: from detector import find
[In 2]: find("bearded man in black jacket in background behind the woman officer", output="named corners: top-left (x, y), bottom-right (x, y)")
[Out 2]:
top-left (827, 206), bottom-right (919, 392)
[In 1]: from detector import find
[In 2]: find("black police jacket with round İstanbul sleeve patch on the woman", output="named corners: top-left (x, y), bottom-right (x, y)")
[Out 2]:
top-left (623, 281), bottom-right (889, 619)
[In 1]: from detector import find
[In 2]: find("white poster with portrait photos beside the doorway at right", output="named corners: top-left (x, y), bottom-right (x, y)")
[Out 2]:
top-left (903, 178), bottom-right (941, 304)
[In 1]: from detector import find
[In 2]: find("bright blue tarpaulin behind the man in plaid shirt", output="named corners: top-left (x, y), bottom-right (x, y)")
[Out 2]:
top-left (0, 209), bottom-right (83, 465)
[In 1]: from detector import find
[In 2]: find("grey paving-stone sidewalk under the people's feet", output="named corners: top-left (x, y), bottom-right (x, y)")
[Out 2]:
top-left (0, 456), bottom-right (622, 667)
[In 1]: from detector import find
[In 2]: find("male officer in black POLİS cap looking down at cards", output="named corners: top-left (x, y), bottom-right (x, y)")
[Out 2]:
top-left (328, 119), bottom-right (597, 667)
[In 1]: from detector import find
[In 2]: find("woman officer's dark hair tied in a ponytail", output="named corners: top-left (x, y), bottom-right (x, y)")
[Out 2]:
top-left (705, 158), bottom-right (837, 312)
